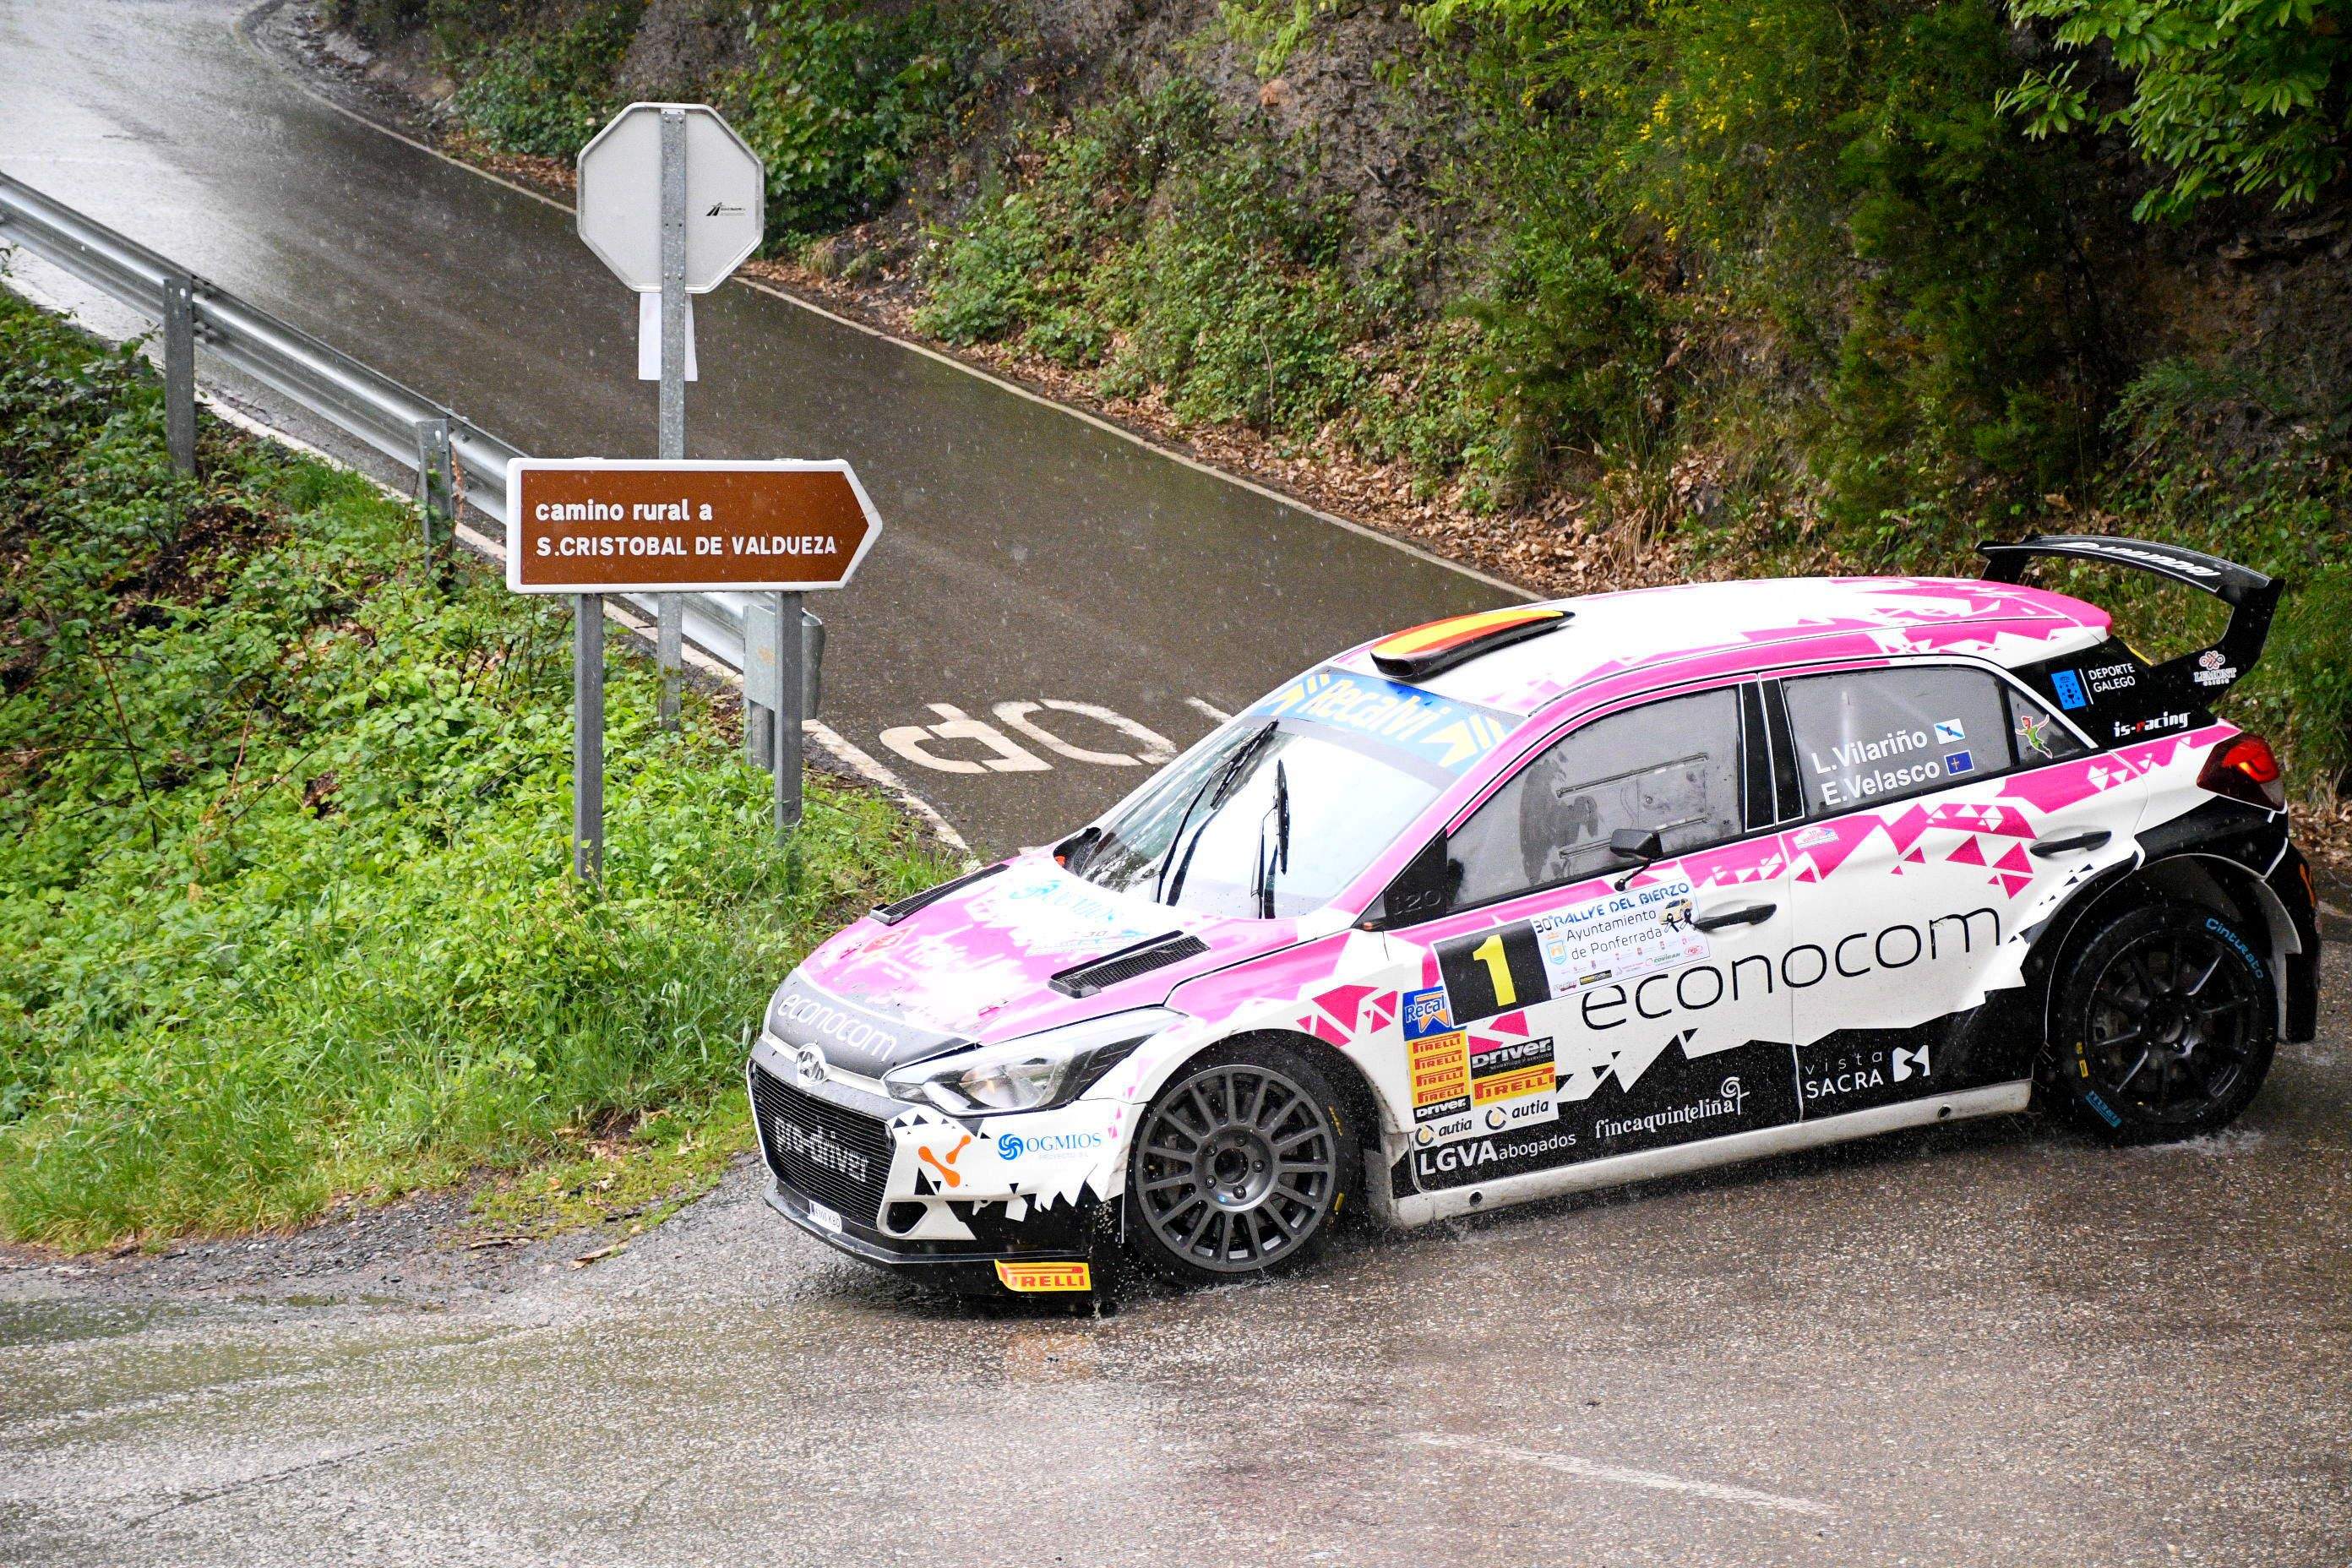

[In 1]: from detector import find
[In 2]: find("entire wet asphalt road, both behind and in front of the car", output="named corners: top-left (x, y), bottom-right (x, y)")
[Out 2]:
top-left (0, 0), bottom-right (2352, 1565)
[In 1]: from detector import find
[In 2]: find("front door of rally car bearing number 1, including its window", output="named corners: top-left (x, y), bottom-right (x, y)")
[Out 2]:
top-left (1390, 687), bottom-right (1797, 1187)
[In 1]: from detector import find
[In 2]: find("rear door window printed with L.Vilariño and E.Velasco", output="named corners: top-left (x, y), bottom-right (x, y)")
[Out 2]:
top-left (1783, 665), bottom-right (2032, 816)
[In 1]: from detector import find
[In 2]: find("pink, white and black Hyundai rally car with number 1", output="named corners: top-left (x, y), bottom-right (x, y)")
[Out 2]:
top-left (748, 536), bottom-right (2319, 1291)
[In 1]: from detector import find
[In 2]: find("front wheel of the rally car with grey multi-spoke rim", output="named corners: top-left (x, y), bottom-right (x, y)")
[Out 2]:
top-left (1127, 1042), bottom-right (1364, 1283)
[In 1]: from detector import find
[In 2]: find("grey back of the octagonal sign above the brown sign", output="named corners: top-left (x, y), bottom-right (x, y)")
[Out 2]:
top-left (579, 103), bottom-right (767, 294)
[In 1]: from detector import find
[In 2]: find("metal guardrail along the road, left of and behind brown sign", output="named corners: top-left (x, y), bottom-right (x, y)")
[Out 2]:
top-left (0, 174), bottom-right (750, 672)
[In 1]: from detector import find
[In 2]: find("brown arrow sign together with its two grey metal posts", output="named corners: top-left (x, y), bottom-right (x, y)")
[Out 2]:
top-left (506, 459), bottom-right (882, 879)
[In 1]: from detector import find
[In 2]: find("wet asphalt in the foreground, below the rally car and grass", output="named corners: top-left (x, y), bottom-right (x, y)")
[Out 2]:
top-left (0, 947), bottom-right (2352, 1568)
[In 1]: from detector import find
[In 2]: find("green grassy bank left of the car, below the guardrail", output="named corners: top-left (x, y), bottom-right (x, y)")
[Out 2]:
top-left (0, 297), bottom-right (948, 1249)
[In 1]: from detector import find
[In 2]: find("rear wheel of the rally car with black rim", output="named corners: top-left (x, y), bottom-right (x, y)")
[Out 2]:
top-left (2049, 903), bottom-right (2279, 1142)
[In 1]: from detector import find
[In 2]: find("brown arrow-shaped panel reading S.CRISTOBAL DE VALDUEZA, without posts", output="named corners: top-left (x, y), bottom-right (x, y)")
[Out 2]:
top-left (506, 459), bottom-right (882, 592)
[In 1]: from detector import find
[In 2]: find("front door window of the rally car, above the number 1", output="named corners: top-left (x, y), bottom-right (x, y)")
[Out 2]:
top-left (1446, 687), bottom-right (1740, 905)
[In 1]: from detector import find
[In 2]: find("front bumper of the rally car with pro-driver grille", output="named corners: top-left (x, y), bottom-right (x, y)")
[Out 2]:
top-left (746, 1037), bottom-right (1117, 1295)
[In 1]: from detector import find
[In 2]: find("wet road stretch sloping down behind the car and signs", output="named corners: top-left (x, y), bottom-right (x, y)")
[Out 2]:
top-left (0, 0), bottom-right (1515, 853)
